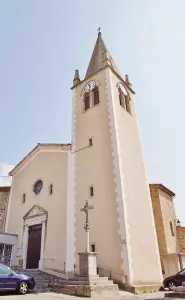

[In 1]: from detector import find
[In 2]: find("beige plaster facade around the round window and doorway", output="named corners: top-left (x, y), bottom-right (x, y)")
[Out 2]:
top-left (7, 150), bottom-right (68, 268)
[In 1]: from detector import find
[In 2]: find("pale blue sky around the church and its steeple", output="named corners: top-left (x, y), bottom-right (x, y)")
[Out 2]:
top-left (0, 0), bottom-right (185, 225)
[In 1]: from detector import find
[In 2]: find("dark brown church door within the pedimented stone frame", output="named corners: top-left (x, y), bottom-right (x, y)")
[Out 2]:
top-left (26, 224), bottom-right (42, 269)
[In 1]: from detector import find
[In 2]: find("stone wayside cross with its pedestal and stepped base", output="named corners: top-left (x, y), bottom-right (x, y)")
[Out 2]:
top-left (53, 201), bottom-right (119, 299)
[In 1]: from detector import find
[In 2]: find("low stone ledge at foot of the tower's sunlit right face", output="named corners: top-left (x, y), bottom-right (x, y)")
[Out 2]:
top-left (123, 284), bottom-right (162, 294)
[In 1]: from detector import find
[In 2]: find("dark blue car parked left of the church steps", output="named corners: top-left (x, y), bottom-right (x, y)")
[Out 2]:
top-left (0, 264), bottom-right (36, 295)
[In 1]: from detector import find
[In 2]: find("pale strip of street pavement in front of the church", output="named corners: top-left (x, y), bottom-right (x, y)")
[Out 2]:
top-left (0, 291), bottom-right (178, 300)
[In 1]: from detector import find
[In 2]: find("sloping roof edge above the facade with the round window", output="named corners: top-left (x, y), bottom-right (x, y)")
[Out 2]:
top-left (9, 143), bottom-right (71, 176)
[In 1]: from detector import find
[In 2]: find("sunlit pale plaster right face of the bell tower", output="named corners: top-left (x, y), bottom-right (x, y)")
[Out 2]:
top-left (109, 71), bottom-right (162, 285)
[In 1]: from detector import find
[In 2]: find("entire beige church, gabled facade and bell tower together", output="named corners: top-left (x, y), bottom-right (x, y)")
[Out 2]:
top-left (1, 32), bottom-right (163, 286)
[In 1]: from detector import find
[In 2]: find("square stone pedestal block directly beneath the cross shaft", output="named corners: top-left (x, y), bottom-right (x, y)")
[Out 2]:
top-left (78, 252), bottom-right (97, 277)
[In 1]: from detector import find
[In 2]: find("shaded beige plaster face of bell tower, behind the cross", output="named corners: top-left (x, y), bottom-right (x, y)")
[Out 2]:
top-left (75, 71), bottom-right (123, 278)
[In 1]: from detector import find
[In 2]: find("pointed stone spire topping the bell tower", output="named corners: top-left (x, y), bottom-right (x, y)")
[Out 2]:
top-left (85, 28), bottom-right (121, 79)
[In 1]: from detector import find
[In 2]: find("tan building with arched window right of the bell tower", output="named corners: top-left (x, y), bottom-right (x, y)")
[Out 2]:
top-left (150, 184), bottom-right (185, 277)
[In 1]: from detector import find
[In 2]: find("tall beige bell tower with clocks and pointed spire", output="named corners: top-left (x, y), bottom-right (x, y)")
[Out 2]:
top-left (68, 32), bottom-right (162, 287)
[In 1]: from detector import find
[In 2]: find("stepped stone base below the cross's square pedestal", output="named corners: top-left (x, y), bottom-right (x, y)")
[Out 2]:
top-left (52, 276), bottom-right (119, 297)
